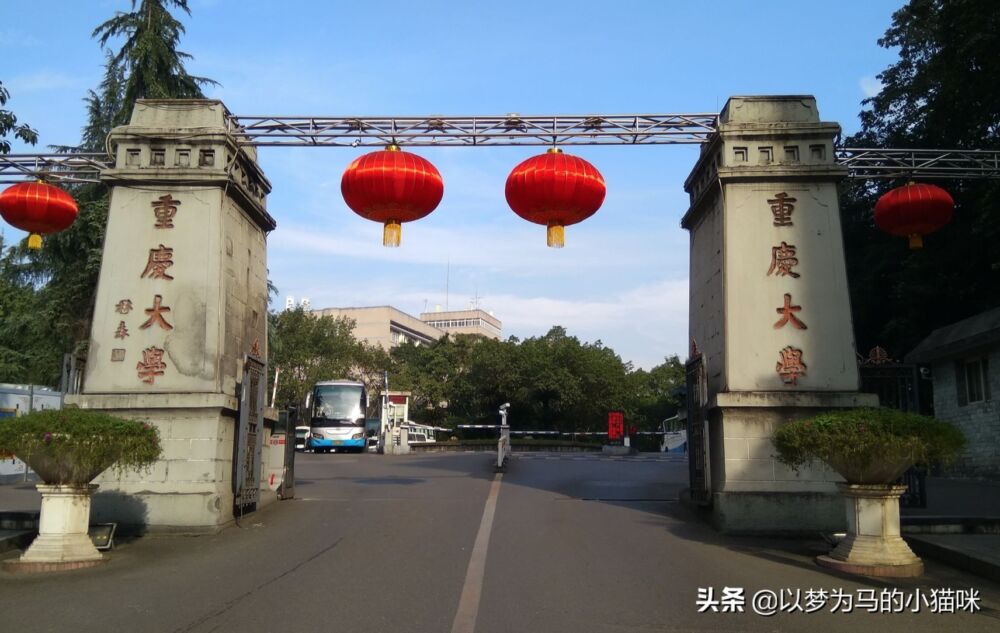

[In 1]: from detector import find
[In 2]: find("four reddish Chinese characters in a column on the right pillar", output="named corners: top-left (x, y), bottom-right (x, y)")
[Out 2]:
top-left (767, 192), bottom-right (807, 386)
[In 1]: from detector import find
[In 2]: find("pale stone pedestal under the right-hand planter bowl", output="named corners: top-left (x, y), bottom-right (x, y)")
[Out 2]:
top-left (816, 484), bottom-right (924, 578)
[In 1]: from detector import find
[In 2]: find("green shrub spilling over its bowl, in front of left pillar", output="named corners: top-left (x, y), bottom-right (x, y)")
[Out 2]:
top-left (0, 408), bottom-right (161, 485)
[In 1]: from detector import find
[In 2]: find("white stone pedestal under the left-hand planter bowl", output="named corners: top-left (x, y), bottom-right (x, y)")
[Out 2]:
top-left (6, 484), bottom-right (105, 571)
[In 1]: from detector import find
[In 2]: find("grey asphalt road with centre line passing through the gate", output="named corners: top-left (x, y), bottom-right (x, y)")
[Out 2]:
top-left (0, 453), bottom-right (1000, 633)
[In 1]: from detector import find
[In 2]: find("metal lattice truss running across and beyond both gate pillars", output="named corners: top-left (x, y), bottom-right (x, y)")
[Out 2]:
top-left (0, 113), bottom-right (1000, 183)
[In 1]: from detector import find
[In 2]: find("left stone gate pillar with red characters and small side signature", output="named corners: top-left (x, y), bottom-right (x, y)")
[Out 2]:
top-left (67, 100), bottom-right (275, 532)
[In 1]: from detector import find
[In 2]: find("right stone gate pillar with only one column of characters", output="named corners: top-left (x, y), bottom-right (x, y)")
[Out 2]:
top-left (682, 96), bottom-right (878, 532)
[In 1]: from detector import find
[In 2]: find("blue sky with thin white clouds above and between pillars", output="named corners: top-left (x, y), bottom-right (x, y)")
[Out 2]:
top-left (0, 0), bottom-right (903, 368)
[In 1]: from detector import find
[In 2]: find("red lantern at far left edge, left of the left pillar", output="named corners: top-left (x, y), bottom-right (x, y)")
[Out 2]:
top-left (0, 181), bottom-right (77, 250)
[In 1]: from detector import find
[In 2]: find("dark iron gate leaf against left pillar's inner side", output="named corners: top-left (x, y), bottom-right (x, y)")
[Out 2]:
top-left (233, 356), bottom-right (267, 516)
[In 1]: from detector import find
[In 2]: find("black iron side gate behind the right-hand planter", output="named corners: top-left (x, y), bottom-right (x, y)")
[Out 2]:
top-left (858, 347), bottom-right (927, 508)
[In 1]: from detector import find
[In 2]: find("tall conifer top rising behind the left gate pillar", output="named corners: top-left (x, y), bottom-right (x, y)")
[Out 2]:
top-left (93, 0), bottom-right (217, 124)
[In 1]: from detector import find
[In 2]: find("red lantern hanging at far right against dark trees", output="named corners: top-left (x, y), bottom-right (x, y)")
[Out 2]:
top-left (875, 182), bottom-right (955, 248)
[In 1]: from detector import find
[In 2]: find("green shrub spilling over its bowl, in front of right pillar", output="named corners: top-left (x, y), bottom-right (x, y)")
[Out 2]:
top-left (774, 408), bottom-right (965, 484)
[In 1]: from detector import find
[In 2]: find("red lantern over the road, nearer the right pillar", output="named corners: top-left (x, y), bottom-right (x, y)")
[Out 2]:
top-left (506, 147), bottom-right (607, 248)
